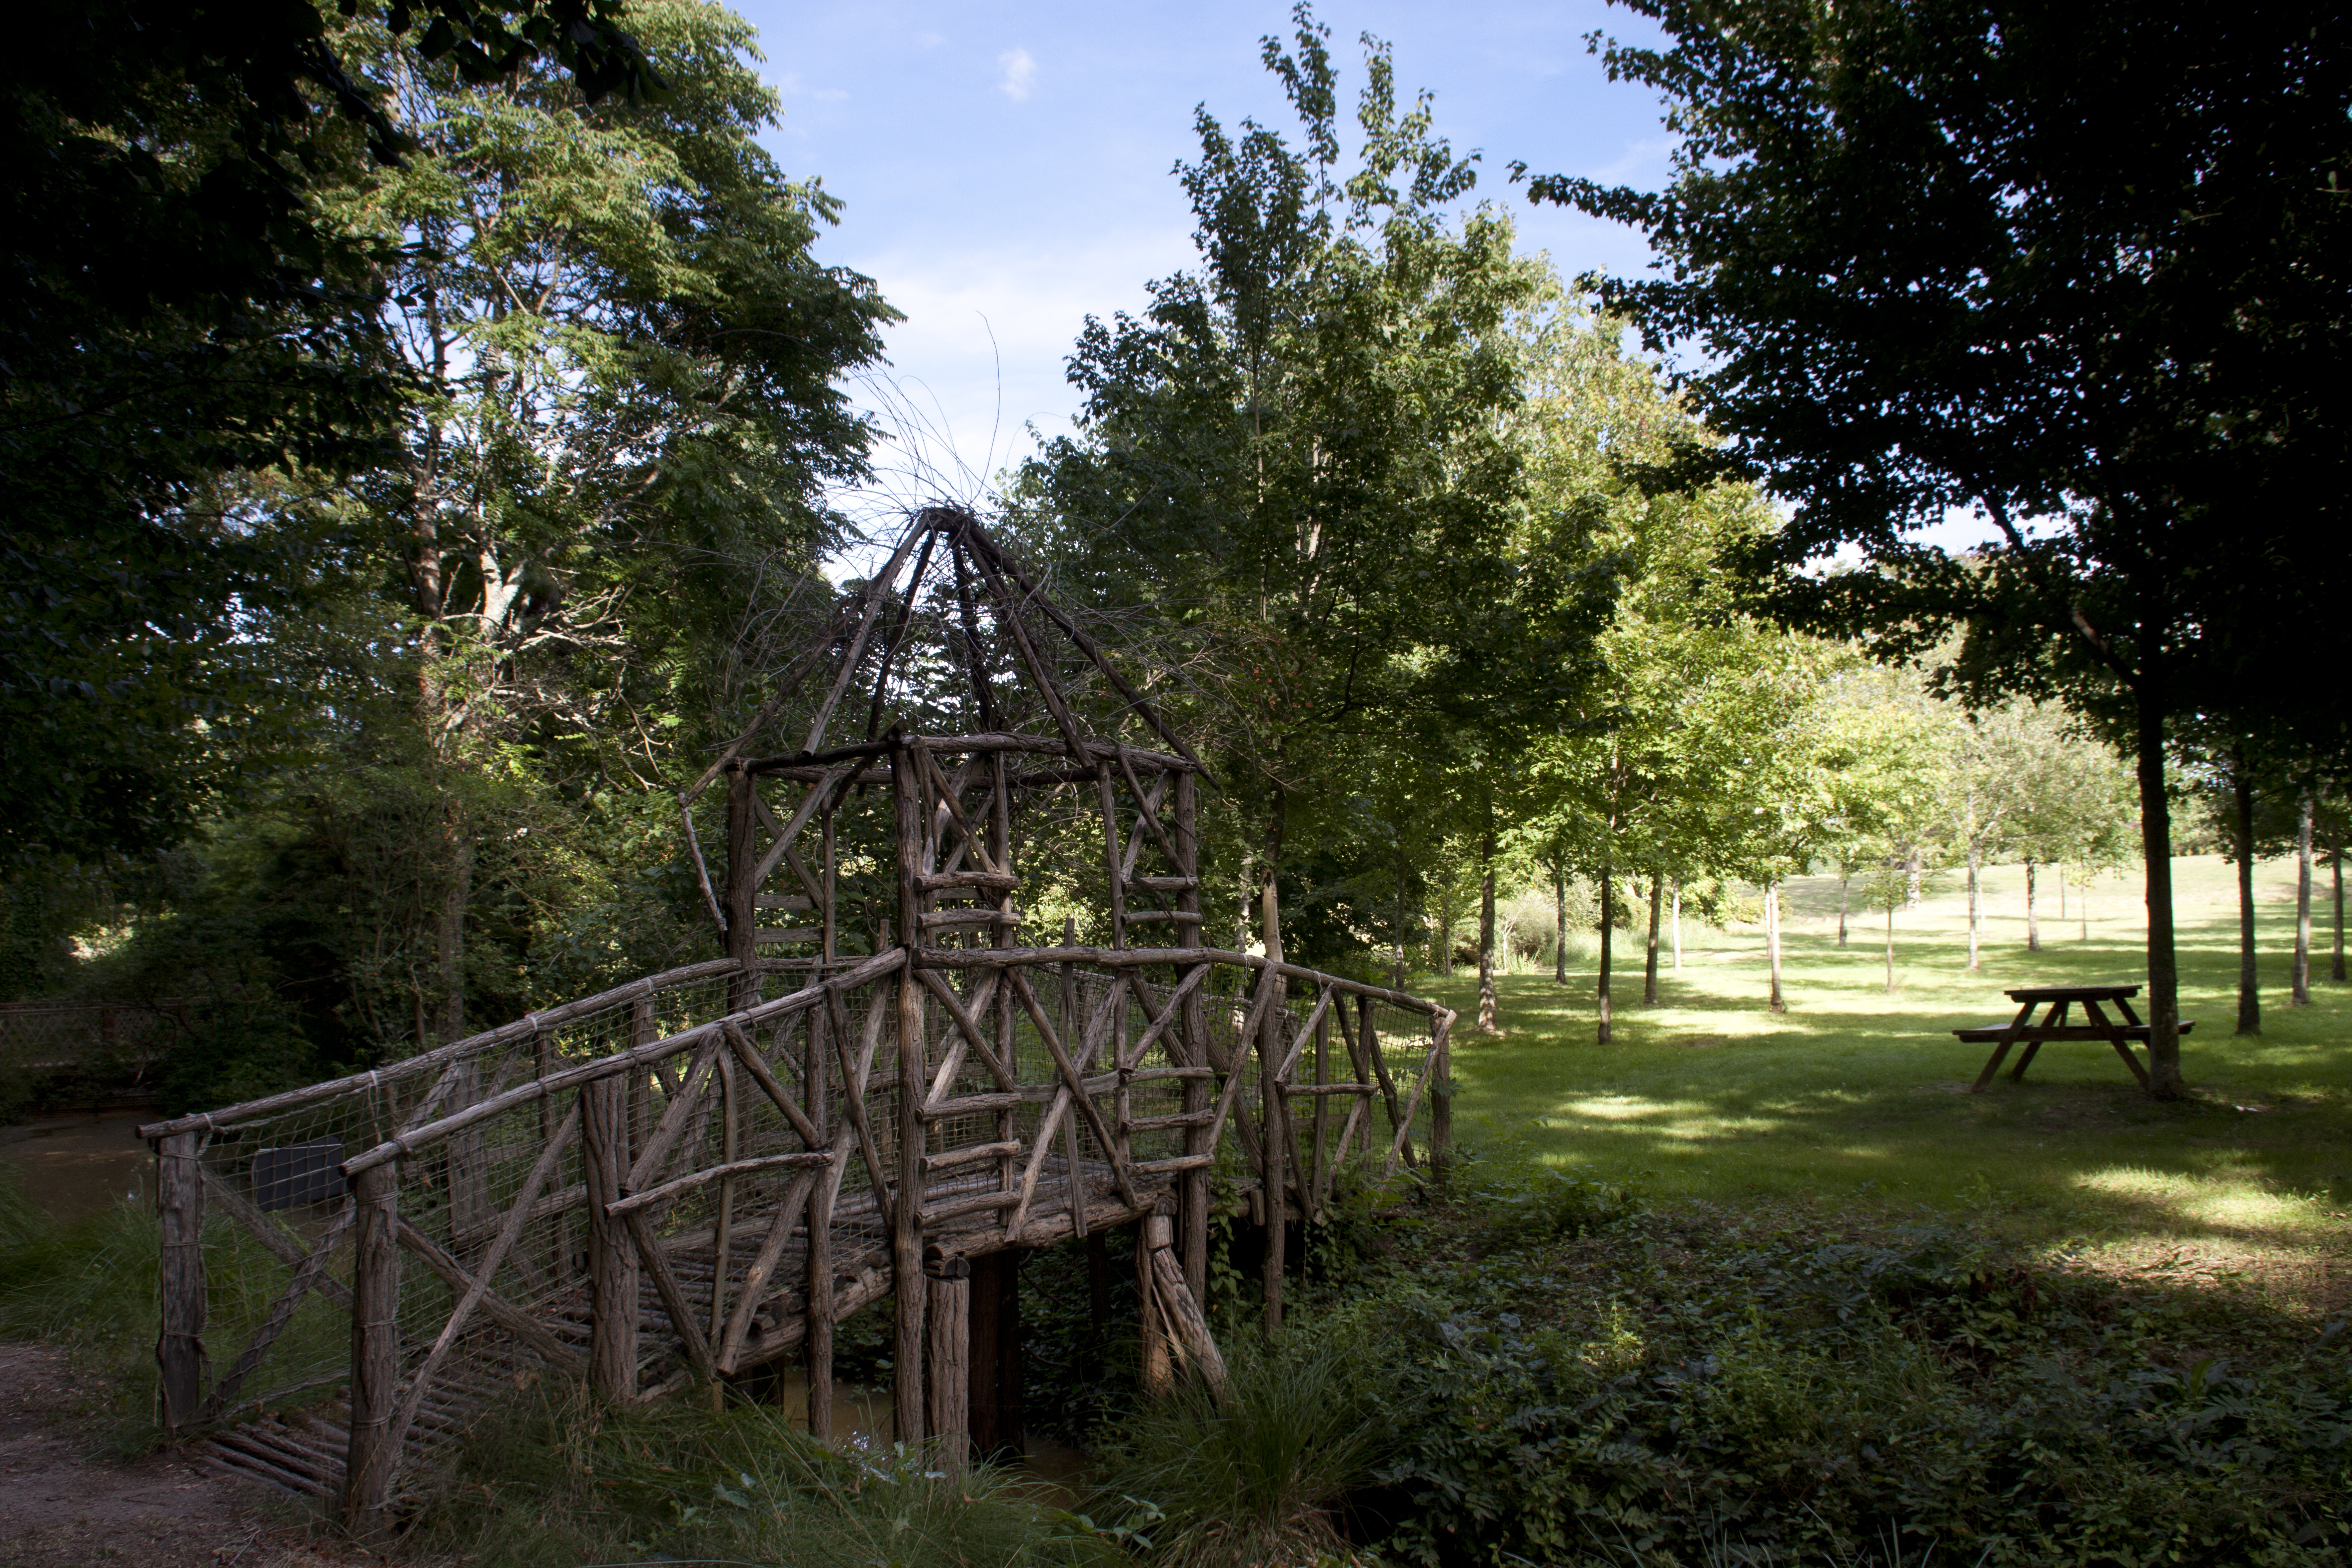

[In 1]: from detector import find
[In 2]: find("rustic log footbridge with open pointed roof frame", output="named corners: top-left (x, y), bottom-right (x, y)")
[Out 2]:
top-left (144, 510), bottom-right (1454, 1530)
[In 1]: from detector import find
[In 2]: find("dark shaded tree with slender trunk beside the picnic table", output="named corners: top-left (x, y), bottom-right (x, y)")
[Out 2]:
top-left (1533, 0), bottom-right (2352, 1098)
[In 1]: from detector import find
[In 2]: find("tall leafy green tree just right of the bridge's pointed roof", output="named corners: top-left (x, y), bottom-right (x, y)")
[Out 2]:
top-left (1021, 4), bottom-right (1573, 959)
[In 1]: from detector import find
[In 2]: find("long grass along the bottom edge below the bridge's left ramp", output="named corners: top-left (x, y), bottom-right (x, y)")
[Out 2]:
top-left (407, 1385), bottom-right (1124, 1568)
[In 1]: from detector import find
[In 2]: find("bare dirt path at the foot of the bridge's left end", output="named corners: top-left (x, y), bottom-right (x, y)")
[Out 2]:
top-left (0, 1345), bottom-right (369, 1568)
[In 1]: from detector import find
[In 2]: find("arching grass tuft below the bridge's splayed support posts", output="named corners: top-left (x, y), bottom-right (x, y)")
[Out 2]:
top-left (1094, 1330), bottom-right (1380, 1568)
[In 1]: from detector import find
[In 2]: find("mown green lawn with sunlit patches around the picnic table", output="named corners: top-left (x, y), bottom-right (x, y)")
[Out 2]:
top-left (1418, 856), bottom-right (2352, 1310)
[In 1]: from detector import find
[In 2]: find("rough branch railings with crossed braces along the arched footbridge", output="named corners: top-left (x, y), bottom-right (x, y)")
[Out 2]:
top-left (144, 947), bottom-right (1451, 1512)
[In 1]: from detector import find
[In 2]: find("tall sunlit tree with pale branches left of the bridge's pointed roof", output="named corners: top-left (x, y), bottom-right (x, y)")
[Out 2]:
top-left (322, 0), bottom-right (894, 1034)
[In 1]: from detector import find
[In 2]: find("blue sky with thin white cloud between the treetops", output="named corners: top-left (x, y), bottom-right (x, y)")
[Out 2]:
top-left (736, 0), bottom-right (1670, 498)
